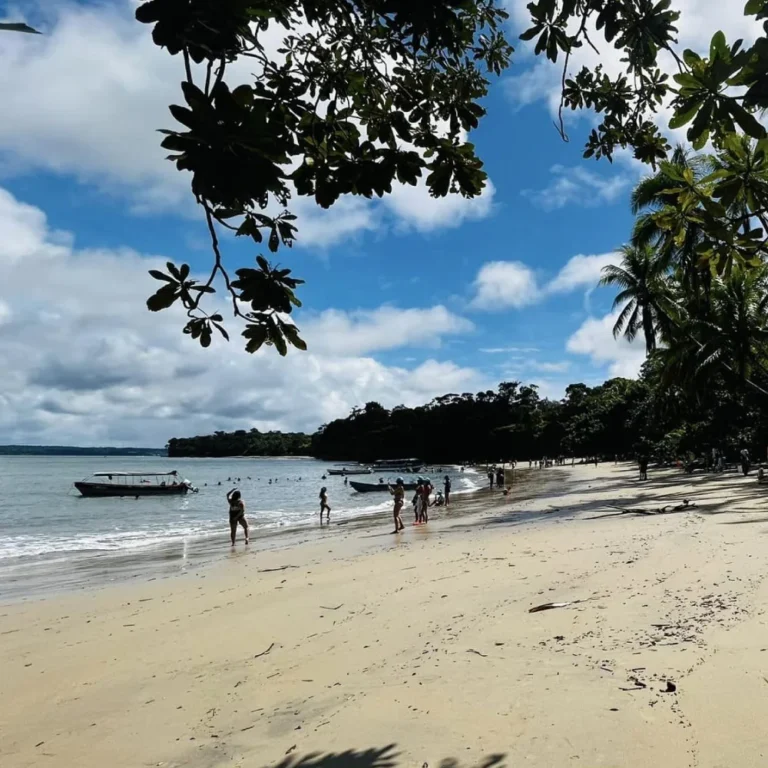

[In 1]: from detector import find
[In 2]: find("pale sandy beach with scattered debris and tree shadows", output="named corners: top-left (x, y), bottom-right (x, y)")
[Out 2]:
top-left (0, 465), bottom-right (768, 768)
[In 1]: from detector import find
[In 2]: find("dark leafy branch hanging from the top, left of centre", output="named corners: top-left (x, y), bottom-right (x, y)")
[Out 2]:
top-left (136, 0), bottom-right (512, 355)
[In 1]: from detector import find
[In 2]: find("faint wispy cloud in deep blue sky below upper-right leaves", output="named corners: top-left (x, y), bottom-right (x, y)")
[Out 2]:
top-left (520, 165), bottom-right (633, 211)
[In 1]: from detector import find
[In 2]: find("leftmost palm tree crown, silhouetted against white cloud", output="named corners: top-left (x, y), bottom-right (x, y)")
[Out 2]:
top-left (600, 245), bottom-right (670, 354)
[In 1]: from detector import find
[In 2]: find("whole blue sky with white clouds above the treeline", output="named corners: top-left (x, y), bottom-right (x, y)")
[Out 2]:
top-left (0, 0), bottom-right (749, 445)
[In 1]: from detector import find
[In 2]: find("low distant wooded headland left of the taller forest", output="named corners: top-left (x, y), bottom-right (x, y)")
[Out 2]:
top-left (168, 429), bottom-right (310, 457)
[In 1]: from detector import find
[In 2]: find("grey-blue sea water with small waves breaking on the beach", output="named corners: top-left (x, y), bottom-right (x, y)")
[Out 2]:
top-left (0, 456), bottom-right (478, 597)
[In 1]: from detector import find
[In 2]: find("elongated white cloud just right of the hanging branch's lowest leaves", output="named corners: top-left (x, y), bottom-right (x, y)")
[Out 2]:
top-left (302, 305), bottom-right (474, 356)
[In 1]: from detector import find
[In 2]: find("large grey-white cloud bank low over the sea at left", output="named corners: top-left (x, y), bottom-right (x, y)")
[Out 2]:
top-left (0, 189), bottom-right (487, 445)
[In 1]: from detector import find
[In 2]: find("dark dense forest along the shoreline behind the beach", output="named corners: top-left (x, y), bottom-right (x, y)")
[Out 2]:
top-left (168, 364), bottom-right (768, 463)
